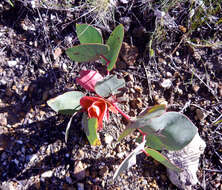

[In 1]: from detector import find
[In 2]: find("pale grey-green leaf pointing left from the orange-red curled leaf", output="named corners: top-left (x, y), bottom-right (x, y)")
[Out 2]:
top-left (47, 91), bottom-right (85, 115)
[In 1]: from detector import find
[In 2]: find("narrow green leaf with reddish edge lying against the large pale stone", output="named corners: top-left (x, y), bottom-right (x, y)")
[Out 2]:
top-left (145, 148), bottom-right (182, 172)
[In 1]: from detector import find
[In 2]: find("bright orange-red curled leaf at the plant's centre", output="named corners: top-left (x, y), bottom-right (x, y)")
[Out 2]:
top-left (80, 96), bottom-right (117, 131)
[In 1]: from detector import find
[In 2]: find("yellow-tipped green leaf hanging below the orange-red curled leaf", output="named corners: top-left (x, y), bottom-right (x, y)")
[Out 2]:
top-left (82, 114), bottom-right (101, 146)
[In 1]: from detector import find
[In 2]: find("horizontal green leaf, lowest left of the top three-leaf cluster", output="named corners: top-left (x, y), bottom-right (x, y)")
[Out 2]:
top-left (66, 43), bottom-right (109, 62)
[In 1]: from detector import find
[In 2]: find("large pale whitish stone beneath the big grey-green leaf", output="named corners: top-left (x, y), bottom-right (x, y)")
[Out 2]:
top-left (163, 133), bottom-right (206, 190)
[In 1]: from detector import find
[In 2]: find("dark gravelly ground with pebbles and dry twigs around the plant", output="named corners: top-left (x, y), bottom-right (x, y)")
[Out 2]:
top-left (0, 0), bottom-right (222, 190)
